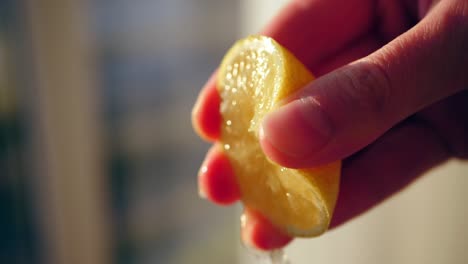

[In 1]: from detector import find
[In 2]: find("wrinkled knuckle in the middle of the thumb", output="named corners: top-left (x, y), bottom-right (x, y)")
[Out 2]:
top-left (334, 62), bottom-right (391, 115)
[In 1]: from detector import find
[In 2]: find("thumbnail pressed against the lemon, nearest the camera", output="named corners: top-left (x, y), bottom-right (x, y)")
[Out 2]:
top-left (259, 97), bottom-right (332, 159)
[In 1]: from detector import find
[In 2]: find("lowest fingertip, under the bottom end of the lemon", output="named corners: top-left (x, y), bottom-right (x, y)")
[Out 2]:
top-left (241, 208), bottom-right (292, 250)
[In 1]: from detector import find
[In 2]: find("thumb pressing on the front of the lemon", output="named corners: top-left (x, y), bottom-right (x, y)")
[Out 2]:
top-left (260, 0), bottom-right (468, 167)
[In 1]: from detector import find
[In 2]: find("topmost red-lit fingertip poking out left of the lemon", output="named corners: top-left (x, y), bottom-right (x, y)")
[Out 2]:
top-left (192, 72), bottom-right (221, 141)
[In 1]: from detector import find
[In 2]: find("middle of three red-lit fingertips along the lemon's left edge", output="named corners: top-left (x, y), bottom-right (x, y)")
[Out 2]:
top-left (198, 145), bottom-right (240, 205)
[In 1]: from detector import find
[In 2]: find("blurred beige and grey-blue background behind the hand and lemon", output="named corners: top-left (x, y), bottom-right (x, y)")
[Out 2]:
top-left (0, 0), bottom-right (468, 264)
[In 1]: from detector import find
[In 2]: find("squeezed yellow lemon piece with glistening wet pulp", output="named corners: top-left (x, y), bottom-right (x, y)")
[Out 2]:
top-left (217, 36), bottom-right (341, 237)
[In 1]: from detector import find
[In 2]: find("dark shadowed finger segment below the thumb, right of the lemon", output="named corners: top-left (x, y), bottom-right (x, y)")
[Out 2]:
top-left (331, 122), bottom-right (448, 227)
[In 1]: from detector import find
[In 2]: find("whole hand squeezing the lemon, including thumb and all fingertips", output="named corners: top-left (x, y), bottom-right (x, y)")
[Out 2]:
top-left (192, 0), bottom-right (468, 249)
